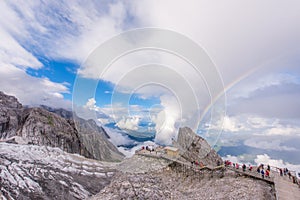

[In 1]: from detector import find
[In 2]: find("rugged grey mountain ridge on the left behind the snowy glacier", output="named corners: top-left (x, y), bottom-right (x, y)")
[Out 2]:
top-left (0, 92), bottom-right (124, 161)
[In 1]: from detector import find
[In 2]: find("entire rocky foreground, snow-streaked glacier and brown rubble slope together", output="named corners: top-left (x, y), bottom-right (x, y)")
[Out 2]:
top-left (0, 134), bottom-right (275, 200)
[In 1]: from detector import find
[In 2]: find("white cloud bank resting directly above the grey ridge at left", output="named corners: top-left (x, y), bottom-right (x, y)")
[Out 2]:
top-left (0, 64), bottom-right (71, 109)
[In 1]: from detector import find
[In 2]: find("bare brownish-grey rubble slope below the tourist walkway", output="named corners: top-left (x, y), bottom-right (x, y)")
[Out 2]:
top-left (91, 157), bottom-right (275, 200)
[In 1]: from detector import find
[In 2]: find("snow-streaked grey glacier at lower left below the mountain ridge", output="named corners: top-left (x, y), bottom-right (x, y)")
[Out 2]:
top-left (0, 143), bottom-right (115, 200)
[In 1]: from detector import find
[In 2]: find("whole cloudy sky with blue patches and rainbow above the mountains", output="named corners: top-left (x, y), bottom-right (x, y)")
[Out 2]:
top-left (0, 0), bottom-right (300, 169)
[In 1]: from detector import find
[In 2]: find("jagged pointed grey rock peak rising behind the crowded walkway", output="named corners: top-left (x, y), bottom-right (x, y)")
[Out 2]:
top-left (174, 127), bottom-right (223, 166)
